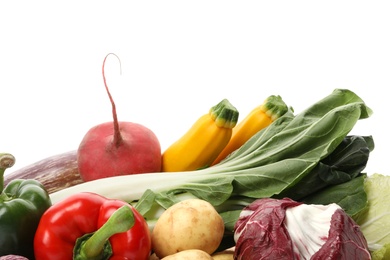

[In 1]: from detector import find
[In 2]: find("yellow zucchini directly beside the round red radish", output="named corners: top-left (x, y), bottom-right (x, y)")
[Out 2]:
top-left (162, 99), bottom-right (239, 172)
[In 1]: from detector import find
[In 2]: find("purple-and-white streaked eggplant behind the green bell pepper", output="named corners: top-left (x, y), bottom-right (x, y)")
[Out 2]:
top-left (4, 150), bottom-right (83, 193)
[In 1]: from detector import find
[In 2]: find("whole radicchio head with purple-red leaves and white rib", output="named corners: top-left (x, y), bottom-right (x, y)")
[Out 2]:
top-left (234, 198), bottom-right (371, 260)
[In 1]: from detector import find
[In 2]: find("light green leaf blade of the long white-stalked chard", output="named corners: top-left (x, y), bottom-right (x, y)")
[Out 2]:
top-left (137, 89), bottom-right (371, 212)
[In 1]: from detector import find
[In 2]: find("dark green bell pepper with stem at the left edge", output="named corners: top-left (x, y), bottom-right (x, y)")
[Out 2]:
top-left (0, 153), bottom-right (51, 259)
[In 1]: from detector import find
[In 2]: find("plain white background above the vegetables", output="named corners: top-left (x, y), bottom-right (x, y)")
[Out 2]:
top-left (0, 1), bottom-right (390, 174)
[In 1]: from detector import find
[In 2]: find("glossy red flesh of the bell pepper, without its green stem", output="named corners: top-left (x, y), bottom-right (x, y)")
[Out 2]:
top-left (34, 193), bottom-right (151, 260)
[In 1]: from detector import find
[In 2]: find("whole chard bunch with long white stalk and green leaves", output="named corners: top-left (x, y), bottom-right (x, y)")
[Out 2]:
top-left (46, 89), bottom-right (384, 258)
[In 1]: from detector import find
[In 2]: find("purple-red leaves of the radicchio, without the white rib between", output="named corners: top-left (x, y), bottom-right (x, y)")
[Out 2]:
top-left (234, 198), bottom-right (371, 260)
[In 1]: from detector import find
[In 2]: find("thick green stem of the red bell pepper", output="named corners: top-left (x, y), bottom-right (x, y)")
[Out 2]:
top-left (74, 205), bottom-right (134, 260)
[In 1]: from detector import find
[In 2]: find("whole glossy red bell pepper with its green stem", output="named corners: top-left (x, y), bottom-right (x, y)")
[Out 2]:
top-left (34, 192), bottom-right (151, 260)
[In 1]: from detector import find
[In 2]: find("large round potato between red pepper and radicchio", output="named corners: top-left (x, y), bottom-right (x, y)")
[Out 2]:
top-left (152, 199), bottom-right (225, 258)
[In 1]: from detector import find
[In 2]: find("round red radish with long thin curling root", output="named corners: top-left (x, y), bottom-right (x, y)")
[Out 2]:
top-left (77, 53), bottom-right (161, 181)
